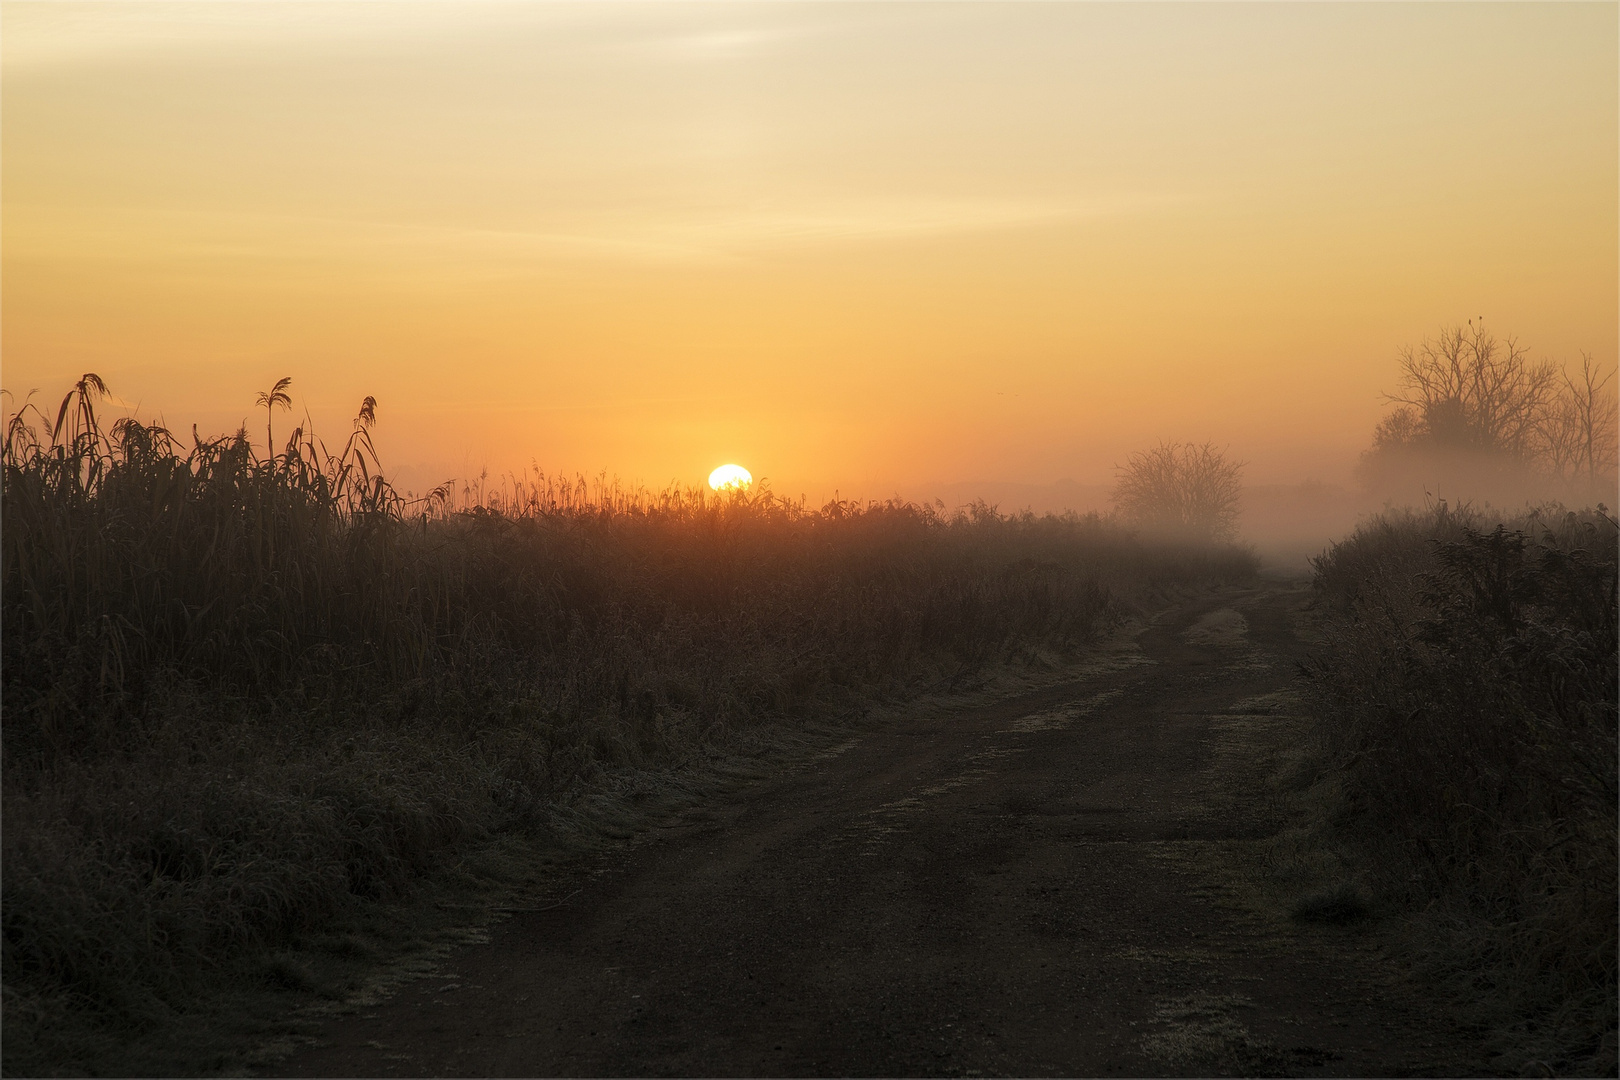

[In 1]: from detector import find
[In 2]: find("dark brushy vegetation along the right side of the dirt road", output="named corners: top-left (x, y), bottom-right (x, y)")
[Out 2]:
top-left (1307, 504), bottom-right (1620, 1075)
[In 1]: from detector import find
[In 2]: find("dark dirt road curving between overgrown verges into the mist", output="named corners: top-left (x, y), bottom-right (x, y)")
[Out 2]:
top-left (275, 585), bottom-right (1484, 1075)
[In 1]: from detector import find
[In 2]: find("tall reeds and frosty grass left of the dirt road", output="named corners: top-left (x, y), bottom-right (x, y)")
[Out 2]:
top-left (0, 376), bottom-right (1256, 1075)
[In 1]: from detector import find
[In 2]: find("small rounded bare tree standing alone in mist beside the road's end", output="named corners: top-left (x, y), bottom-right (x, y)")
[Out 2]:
top-left (1113, 442), bottom-right (1243, 541)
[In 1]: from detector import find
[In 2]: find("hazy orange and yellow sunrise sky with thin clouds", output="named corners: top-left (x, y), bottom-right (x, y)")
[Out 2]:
top-left (0, 2), bottom-right (1620, 500)
